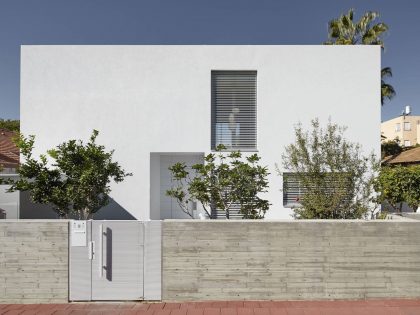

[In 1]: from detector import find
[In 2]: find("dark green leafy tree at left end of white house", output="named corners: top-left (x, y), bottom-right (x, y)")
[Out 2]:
top-left (10, 130), bottom-right (131, 219)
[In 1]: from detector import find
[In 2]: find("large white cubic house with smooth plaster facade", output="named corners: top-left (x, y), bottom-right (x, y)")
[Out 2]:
top-left (21, 45), bottom-right (380, 220)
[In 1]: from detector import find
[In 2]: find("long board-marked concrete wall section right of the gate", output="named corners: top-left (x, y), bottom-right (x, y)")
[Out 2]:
top-left (162, 220), bottom-right (420, 301)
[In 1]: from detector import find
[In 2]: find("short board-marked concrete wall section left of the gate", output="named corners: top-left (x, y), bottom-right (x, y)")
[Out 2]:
top-left (0, 220), bottom-right (68, 303)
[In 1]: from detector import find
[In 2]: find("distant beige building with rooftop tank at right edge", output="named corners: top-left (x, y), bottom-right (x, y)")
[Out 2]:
top-left (381, 107), bottom-right (420, 147)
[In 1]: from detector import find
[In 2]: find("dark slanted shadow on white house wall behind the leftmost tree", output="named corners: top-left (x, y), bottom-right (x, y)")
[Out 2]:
top-left (20, 192), bottom-right (136, 220)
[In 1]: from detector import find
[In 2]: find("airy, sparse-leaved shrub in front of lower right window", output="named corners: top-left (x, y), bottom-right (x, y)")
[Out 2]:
top-left (280, 119), bottom-right (377, 219)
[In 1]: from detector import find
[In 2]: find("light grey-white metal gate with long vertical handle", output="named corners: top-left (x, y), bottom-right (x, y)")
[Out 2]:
top-left (70, 220), bottom-right (161, 301)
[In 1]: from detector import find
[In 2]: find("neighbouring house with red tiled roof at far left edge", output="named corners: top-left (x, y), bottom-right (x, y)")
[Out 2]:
top-left (0, 129), bottom-right (19, 219)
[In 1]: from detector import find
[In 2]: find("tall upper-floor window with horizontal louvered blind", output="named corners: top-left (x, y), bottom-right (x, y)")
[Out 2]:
top-left (211, 71), bottom-right (257, 151)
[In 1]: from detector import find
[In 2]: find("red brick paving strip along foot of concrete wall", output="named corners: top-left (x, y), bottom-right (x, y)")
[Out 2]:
top-left (0, 299), bottom-right (420, 315)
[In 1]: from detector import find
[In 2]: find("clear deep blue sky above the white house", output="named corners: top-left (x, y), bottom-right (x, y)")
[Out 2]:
top-left (0, 0), bottom-right (420, 119)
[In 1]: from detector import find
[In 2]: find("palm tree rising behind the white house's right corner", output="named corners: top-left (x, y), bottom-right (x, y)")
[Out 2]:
top-left (324, 9), bottom-right (396, 105)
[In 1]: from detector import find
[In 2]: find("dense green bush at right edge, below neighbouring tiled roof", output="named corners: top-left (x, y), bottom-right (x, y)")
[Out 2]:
top-left (374, 165), bottom-right (420, 212)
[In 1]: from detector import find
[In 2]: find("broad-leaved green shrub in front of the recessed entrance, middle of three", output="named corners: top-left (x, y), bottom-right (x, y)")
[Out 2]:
top-left (167, 145), bottom-right (269, 219)
